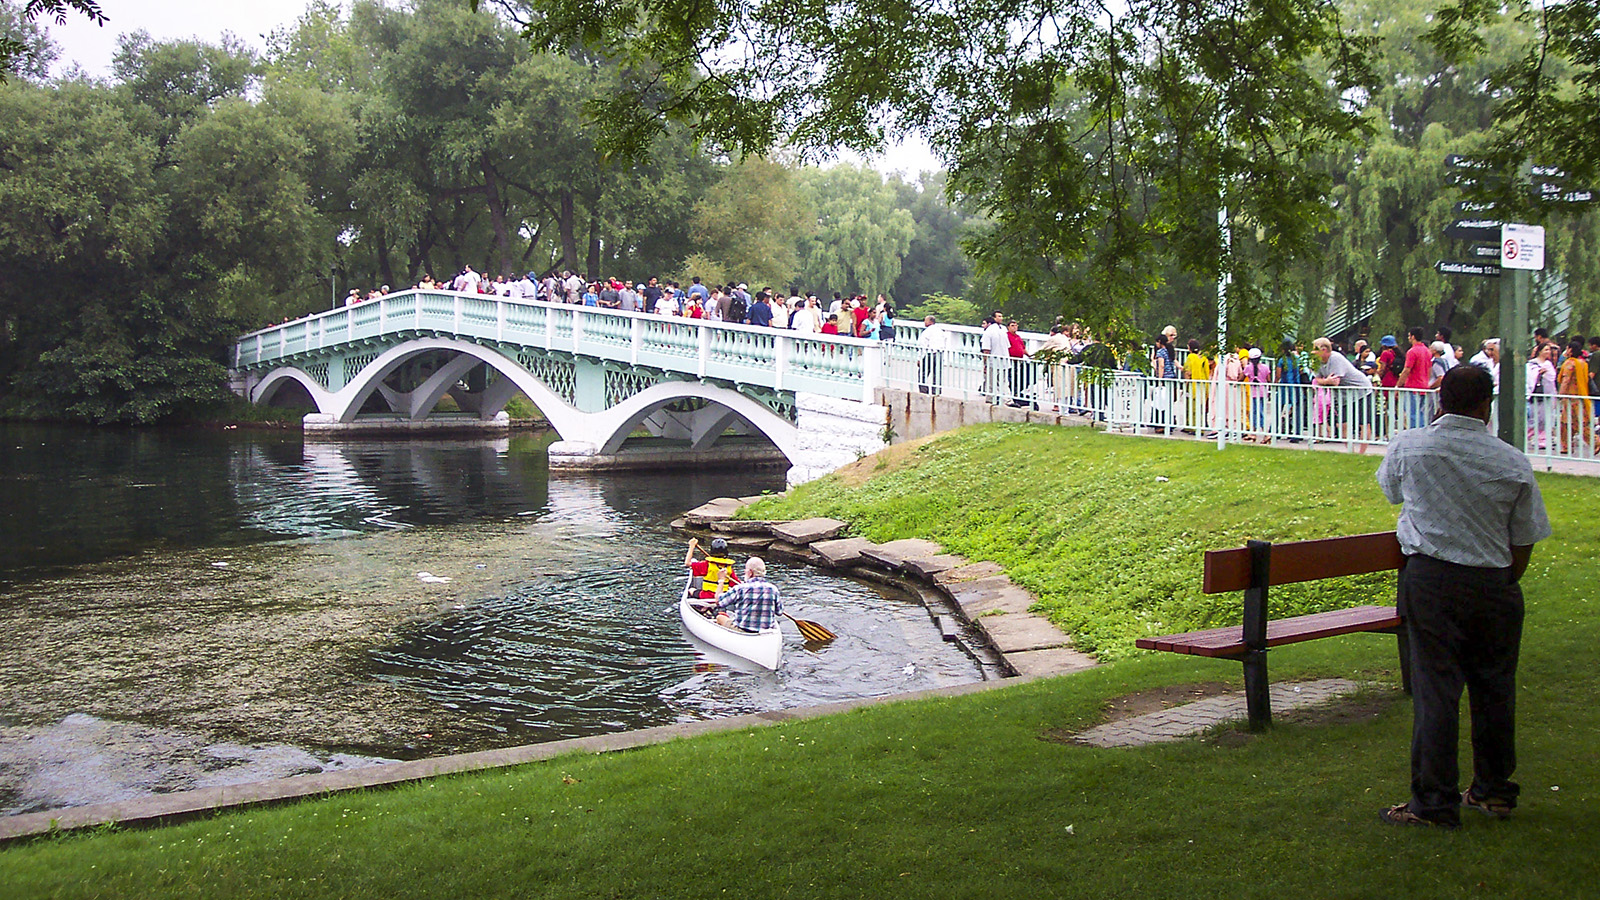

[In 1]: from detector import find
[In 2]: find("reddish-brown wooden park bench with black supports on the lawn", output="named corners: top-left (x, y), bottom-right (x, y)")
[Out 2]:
top-left (1134, 532), bottom-right (1411, 730)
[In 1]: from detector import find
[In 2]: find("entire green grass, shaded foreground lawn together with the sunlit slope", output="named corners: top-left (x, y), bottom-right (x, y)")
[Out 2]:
top-left (0, 426), bottom-right (1600, 900)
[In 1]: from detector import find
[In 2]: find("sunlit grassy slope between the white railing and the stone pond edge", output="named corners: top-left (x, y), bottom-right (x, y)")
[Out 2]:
top-left (747, 426), bottom-right (1414, 660)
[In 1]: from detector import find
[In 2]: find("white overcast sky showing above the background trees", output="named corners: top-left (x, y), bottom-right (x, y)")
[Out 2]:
top-left (40, 0), bottom-right (941, 178)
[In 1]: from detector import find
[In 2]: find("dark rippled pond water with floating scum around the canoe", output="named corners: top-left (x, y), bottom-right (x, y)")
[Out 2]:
top-left (0, 424), bottom-right (984, 812)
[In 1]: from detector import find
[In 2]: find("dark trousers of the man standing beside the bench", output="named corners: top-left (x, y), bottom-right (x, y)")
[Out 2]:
top-left (1400, 556), bottom-right (1523, 822)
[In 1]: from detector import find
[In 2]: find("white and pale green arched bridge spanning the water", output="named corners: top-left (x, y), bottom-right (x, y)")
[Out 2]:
top-left (234, 291), bottom-right (888, 482)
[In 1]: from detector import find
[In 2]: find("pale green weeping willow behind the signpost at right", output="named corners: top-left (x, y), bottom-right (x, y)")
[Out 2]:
top-left (1306, 0), bottom-right (1600, 338)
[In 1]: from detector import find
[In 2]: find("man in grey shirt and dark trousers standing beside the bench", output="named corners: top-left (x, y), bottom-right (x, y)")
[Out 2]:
top-left (1378, 365), bottom-right (1550, 828)
